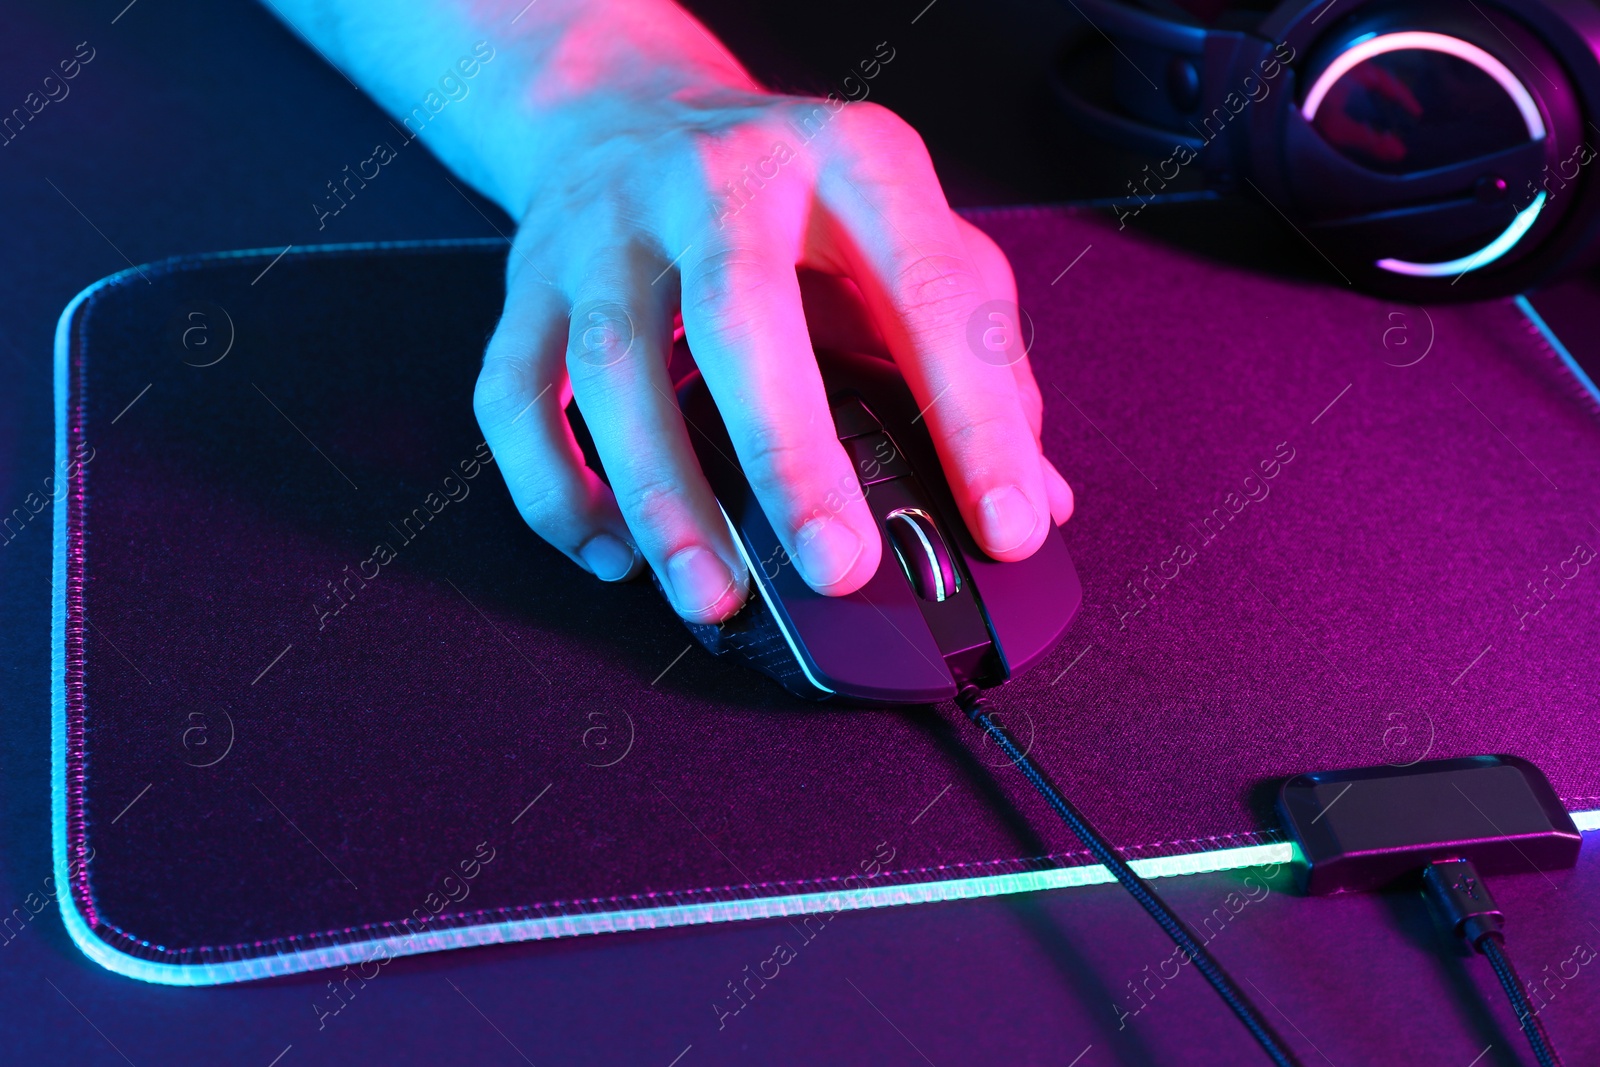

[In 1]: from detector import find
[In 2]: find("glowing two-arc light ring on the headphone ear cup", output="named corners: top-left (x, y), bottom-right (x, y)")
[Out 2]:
top-left (1301, 30), bottom-right (1546, 278)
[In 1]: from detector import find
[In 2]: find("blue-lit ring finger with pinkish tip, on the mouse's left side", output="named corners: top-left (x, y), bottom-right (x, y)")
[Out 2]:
top-left (565, 242), bottom-right (749, 622)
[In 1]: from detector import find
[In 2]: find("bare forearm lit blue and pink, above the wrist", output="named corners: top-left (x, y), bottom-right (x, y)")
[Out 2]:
top-left (264, 0), bottom-right (760, 219)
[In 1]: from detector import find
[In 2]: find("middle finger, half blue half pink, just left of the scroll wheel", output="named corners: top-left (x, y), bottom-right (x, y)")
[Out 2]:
top-left (680, 213), bottom-right (882, 595)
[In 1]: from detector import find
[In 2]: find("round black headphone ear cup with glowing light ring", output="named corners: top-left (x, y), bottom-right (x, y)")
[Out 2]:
top-left (1251, 3), bottom-right (1595, 302)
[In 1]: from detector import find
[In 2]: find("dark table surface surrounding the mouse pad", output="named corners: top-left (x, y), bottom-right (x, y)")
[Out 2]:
top-left (0, 0), bottom-right (1600, 1067)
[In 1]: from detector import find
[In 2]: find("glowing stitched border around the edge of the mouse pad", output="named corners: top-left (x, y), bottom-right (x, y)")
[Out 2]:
top-left (51, 230), bottom-right (1600, 985)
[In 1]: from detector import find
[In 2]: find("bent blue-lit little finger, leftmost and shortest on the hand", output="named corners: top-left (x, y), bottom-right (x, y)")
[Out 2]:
top-left (472, 270), bottom-right (640, 582)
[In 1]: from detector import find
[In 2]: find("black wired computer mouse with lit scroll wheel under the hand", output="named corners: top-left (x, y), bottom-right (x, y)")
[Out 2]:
top-left (678, 350), bottom-right (1083, 704)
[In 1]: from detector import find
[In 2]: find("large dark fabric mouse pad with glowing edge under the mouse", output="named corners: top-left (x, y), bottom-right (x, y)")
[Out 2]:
top-left (53, 210), bottom-right (1600, 984)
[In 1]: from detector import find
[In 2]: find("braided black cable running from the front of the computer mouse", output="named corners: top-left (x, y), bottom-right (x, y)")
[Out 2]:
top-left (955, 685), bottom-right (1305, 1067)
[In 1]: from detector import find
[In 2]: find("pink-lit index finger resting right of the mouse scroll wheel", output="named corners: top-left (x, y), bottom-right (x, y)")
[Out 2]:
top-left (818, 104), bottom-right (1054, 560)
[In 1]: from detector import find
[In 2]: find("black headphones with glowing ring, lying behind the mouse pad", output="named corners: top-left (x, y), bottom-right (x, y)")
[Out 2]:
top-left (1053, 0), bottom-right (1600, 302)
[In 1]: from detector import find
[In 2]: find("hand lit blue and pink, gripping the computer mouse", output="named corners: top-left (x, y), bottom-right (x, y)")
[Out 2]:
top-left (474, 12), bottom-right (1072, 622)
